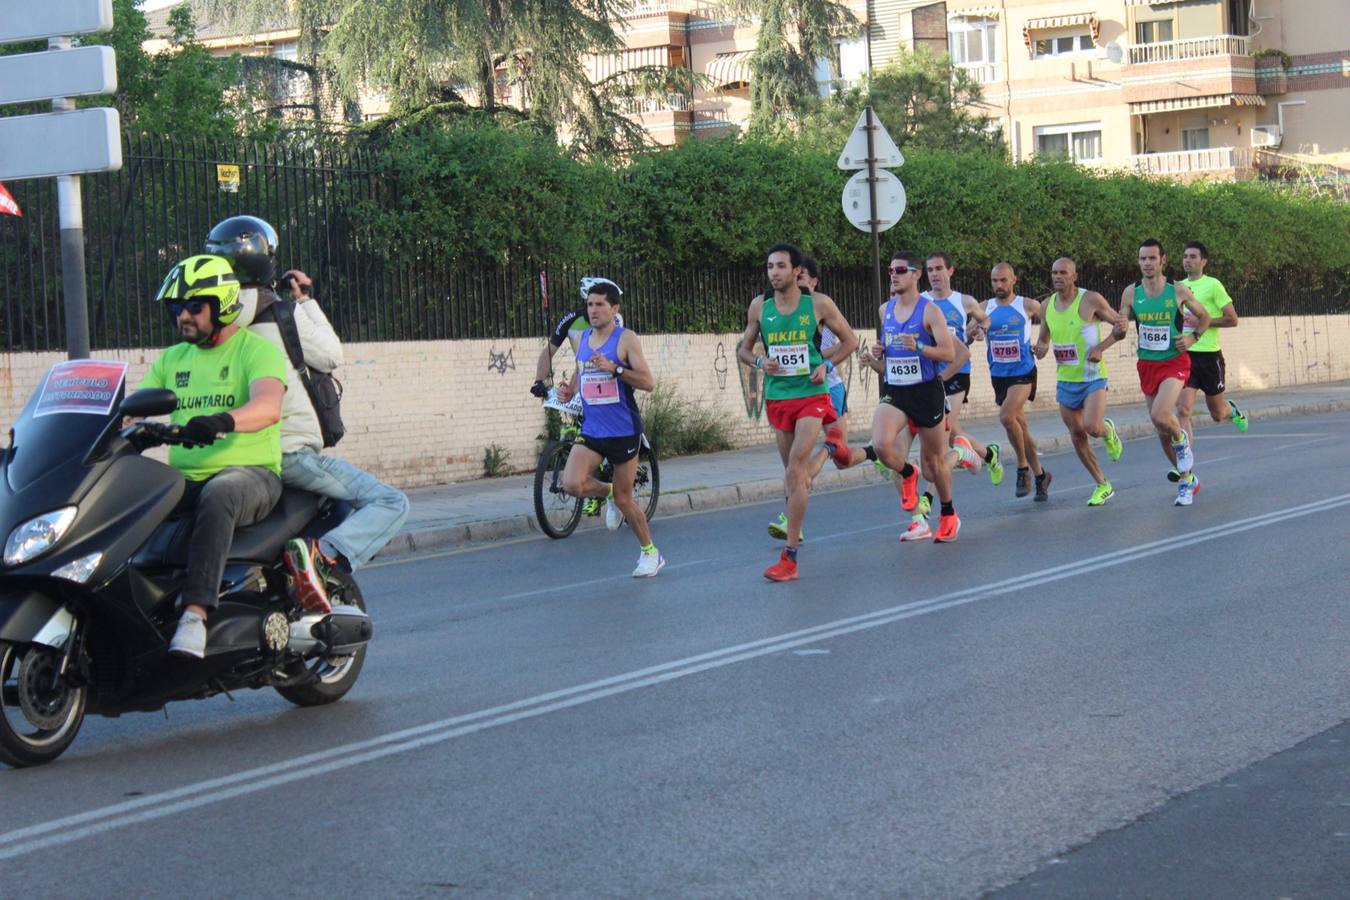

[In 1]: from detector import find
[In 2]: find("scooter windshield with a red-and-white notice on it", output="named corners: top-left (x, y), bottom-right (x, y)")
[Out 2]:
top-left (5, 359), bottom-right (127, 491)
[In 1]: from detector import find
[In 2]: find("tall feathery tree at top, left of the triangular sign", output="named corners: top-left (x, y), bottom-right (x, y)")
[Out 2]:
top-left (720, 0), bottom-right (860, 134)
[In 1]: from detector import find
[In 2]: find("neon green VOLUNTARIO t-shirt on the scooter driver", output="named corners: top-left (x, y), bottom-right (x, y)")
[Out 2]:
top-left (140, 323), bottom-right (286, 482)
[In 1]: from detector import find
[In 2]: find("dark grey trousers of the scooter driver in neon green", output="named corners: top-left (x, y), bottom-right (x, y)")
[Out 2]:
top-left (178, 466), bottom-right (281, 610)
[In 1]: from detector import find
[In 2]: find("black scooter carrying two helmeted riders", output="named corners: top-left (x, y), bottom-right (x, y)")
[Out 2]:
top-left (0, 372), bottom-right (373, 766)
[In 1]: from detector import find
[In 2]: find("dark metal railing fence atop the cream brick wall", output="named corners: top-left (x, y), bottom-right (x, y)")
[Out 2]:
top-left (0, 135), bottom-right (1350, 352)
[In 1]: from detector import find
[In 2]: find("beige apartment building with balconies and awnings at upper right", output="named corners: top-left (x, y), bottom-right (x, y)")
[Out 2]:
top-left (868, 0), bottom-right (1350, 178)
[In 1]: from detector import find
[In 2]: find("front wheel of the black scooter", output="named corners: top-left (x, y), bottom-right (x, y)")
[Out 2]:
top-left (0, 641), bottom-right (88, 768)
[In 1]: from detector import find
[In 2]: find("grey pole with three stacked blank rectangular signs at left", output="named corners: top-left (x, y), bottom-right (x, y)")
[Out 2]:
top-left (0, 0), bottom-right (122, 359)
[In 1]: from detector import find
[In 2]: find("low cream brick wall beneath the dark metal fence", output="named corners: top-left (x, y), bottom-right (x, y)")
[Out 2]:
top-left (0, 316), bottom-right (1350, 487)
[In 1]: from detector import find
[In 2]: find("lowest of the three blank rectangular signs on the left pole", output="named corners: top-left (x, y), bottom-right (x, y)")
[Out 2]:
top-left (0, 109), bottom-right (122, 181)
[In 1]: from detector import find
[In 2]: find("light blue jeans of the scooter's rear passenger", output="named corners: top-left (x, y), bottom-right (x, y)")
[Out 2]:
top-left (281, 449), bottom-right (408, 569)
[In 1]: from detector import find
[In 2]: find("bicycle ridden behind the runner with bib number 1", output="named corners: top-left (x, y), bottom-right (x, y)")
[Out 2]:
top-left (535, 389), bottom-right (662, 540)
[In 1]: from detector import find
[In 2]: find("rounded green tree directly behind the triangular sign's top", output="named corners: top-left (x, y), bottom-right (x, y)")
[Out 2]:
top-left (801, 47), bottom-right (1007, 157)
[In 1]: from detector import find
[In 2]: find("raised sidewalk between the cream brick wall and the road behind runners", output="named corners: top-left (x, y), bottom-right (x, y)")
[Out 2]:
top-left (381, 382), bottom-right (1350, 556)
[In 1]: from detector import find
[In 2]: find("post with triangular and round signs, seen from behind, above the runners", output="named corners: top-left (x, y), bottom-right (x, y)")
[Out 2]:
top-left (837, 107), bottom-right (905, 301)
